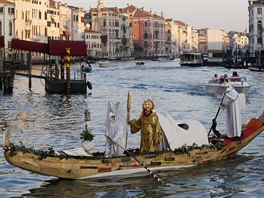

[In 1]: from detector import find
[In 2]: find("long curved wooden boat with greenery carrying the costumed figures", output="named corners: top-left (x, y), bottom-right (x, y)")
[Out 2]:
top-left (3, 112), bottom-right (264, 179)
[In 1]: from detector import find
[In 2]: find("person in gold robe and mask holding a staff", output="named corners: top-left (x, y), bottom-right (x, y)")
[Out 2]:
top-left (129, 99), bottom-right (163, 153)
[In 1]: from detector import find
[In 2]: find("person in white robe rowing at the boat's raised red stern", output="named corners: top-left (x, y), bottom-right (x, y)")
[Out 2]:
top-left (221, 83), bottom-right (245, 138)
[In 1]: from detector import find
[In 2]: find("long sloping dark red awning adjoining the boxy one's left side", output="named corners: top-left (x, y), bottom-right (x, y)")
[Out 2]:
top-left (11, 39), bottom-right (49, 54)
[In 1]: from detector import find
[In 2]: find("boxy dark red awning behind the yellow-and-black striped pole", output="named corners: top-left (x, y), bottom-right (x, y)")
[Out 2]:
top-left (49, 40), bottom-right (87, 56)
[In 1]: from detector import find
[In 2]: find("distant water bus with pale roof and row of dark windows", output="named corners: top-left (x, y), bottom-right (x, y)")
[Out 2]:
top-left (180, 52), bottom-right (203, 67)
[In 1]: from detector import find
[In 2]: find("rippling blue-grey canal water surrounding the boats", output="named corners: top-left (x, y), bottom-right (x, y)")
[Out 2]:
top-left (0, 61), bottom-right (264, 198)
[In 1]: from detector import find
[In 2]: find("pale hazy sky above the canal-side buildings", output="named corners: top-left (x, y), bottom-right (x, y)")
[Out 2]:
top-left (56, 0), bottom-right (248, 32)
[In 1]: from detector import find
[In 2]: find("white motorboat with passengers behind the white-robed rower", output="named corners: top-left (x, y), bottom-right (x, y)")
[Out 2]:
top-left (205, 76), bottom-right (251, 95)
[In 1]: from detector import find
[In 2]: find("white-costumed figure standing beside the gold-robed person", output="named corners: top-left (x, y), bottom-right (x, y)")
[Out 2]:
top-left (105, 101), bottom-right (128, 157)
